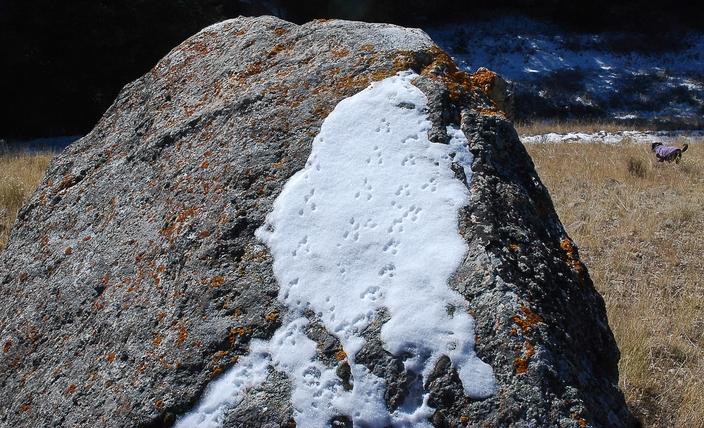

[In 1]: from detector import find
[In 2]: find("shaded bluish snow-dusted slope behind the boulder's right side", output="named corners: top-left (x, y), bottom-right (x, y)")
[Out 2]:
top-left (426, 16), bottom-right (704, 127)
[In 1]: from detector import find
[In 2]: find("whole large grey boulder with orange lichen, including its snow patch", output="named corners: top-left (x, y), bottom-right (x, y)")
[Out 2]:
top-left (0, 17), bottom-right (631, 427)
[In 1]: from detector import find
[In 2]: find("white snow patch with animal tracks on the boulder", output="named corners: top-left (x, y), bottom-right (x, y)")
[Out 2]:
top-left (178, 72), bottom-right (496, 427)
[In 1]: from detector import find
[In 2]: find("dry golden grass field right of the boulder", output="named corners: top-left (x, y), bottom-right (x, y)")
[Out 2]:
top-left (527, 142), bottom-right (704, 427)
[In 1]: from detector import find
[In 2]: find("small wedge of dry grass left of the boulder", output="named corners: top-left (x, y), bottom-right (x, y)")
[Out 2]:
top-left (0, 152), bottom-right (53, 250)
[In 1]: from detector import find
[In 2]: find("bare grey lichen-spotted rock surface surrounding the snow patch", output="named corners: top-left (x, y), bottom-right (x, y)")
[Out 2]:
top-left (0, 17), bottom-right (632, 427)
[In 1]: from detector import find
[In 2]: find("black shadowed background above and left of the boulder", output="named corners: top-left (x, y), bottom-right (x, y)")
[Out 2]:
top-left (0, 0), bottom-right (704, 137)
